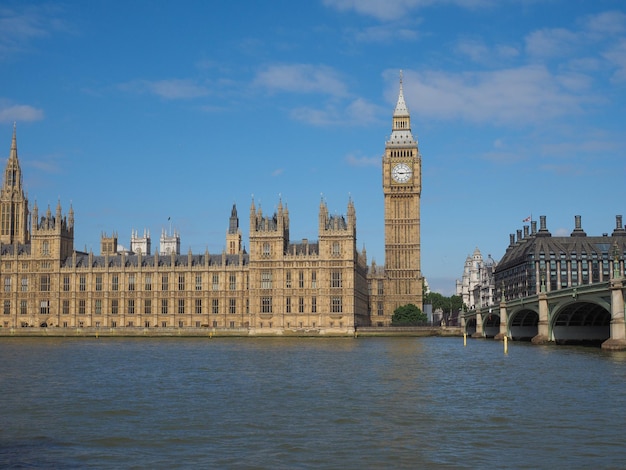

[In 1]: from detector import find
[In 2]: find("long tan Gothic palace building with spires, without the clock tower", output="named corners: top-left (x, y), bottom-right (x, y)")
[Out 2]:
top-left (0, 130), bottom-right (369, 334)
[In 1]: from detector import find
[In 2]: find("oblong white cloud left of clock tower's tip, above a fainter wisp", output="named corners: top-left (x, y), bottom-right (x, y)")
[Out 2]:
top-left (254, 64), bottom-right (347, 96)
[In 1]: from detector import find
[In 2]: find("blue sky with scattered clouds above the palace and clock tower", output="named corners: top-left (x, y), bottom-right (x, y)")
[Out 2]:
top-left (0, 0), bottom-right (626, 295)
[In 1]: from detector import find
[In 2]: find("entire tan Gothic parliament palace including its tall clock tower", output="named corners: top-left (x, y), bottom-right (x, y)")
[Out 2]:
top-left (0, 79), bottom-right (423, 335)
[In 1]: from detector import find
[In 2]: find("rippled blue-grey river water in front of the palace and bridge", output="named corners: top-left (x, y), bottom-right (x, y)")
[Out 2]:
top-left (0, 338), bottom-right (626, 470)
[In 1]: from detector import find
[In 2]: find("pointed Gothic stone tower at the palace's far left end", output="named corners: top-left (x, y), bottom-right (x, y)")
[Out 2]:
top-left (0, 124), bottom-right (29, 244)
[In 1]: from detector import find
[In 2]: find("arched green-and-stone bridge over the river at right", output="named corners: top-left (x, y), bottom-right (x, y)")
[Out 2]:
top-left (461, 277), bottom-right (626, 349)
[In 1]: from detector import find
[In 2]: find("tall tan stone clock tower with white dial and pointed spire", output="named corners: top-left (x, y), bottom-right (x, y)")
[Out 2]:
top-left (382, 72), bottom-right (423, 319)
